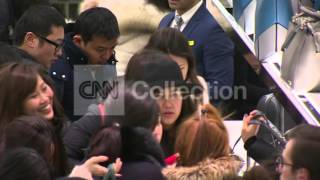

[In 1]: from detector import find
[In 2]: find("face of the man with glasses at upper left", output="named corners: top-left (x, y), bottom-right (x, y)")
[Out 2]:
top-left (32, 26), bottom-right (64, 69)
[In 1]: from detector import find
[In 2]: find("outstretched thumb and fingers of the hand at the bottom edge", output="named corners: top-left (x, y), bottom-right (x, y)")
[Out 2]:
top-left (81, 156), bottom-right (108, 176)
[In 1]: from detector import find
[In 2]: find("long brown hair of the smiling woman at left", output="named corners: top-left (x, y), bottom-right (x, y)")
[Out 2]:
top-left (0, 62), bottom-right (64, 133)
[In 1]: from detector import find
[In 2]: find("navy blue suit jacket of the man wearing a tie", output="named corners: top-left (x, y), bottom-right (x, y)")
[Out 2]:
top-left (159, 1), bottom-right (234, 104)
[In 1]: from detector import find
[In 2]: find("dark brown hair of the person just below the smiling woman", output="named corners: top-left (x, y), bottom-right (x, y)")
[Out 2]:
top-left (4, 116), bottom-right (67, 176)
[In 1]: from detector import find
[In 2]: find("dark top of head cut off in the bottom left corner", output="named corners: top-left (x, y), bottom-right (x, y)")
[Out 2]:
top-left (0, 147), bottom-right (53, 180)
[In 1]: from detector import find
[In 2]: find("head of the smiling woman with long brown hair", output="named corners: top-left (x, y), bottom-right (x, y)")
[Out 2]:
top-left (0, 63), bottom-right (65, 134)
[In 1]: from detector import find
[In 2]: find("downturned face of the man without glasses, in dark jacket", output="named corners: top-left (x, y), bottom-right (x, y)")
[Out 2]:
top-left (79, 36), bottom-right (118, 64)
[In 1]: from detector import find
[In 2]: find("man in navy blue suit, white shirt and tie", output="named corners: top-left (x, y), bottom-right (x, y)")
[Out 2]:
top-left (159, 0), bottom-right (234, 105)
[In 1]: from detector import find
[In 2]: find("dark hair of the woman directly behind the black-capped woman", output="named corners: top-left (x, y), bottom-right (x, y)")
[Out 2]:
top-left (145, 28), bottom-right (201, 86)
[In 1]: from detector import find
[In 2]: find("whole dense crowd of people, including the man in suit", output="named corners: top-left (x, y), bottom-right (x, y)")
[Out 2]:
top-left (0, 0), bottom-right (320, 180)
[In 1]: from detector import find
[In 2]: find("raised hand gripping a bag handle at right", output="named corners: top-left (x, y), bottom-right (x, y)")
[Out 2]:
top-left (241, 110), bottom-right (260, 143)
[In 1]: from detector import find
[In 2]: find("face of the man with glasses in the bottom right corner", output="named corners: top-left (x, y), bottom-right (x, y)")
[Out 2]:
top-left (278, 140), bottom-right (296, 180)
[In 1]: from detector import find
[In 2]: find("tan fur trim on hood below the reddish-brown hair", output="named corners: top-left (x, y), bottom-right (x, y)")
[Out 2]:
top-left (162, 155), bottom-right (242, 180)
